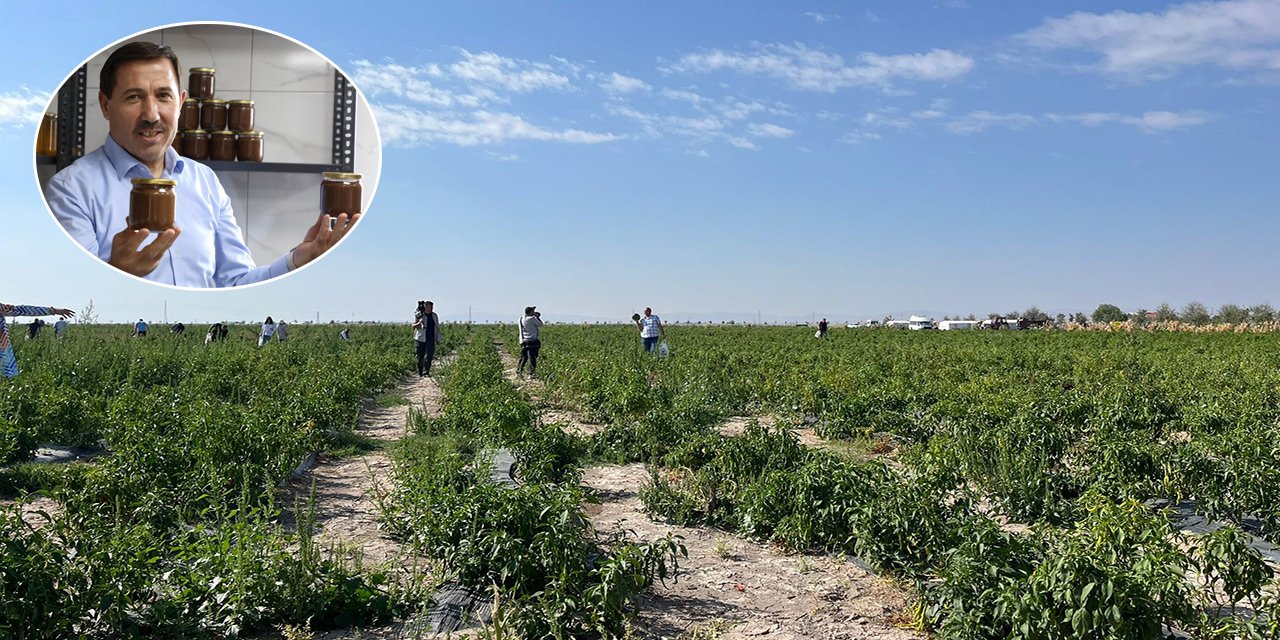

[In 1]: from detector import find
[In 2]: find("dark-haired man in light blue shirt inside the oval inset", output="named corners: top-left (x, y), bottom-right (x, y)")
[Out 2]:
top-left (46, 42), bottom-right (360, 288)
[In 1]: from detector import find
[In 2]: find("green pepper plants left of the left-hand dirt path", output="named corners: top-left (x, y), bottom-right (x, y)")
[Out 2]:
top-left (0, 326), bottom-right (466, 637)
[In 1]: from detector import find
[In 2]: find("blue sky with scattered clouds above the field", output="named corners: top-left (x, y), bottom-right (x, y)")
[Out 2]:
top-left (0, 0), bottom-right (1280, 321)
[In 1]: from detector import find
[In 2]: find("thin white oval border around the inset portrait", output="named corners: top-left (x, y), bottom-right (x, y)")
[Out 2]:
top-left (31, 20), bottom-right (383, 292)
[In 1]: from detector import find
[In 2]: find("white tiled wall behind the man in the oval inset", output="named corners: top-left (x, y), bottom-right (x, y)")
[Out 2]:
top-left (49, 24), bottom-right (381, 265)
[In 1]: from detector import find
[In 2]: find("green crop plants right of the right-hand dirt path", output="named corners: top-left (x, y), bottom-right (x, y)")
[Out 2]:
top-left (522, 326), bottom-right (1280, 639)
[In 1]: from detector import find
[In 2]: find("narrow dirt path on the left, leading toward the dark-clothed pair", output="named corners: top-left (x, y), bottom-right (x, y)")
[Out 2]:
top-left (289, 362), bottom-right (443, 566)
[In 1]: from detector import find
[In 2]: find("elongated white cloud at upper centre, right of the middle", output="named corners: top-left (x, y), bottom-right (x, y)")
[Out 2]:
top-left (671, 45), bottom-right (974, 92)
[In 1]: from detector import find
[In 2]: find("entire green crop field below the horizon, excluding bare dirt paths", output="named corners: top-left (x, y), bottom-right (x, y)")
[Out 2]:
top-left (0, 325), bottom-right (1280, 639)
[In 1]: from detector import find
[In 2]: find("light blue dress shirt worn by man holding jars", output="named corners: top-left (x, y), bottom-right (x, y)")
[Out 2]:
top-left (45, 136), bottom-right (289, 288)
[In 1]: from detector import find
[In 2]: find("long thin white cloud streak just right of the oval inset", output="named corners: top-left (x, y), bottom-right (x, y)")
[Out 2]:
top-left (374, 105), bottom-right (621, 147)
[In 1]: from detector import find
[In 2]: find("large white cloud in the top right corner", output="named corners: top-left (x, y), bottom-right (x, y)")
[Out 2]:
top-left (1019, 0), bottom-right (1280, 77)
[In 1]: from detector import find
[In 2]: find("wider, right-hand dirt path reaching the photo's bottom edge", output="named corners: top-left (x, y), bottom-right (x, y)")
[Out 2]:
top-left (499, 348), bottom-right (924, 640)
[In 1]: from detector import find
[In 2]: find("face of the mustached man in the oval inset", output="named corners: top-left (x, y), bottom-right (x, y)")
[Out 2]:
top-left (97, 58), bottom-right (186, 174)
